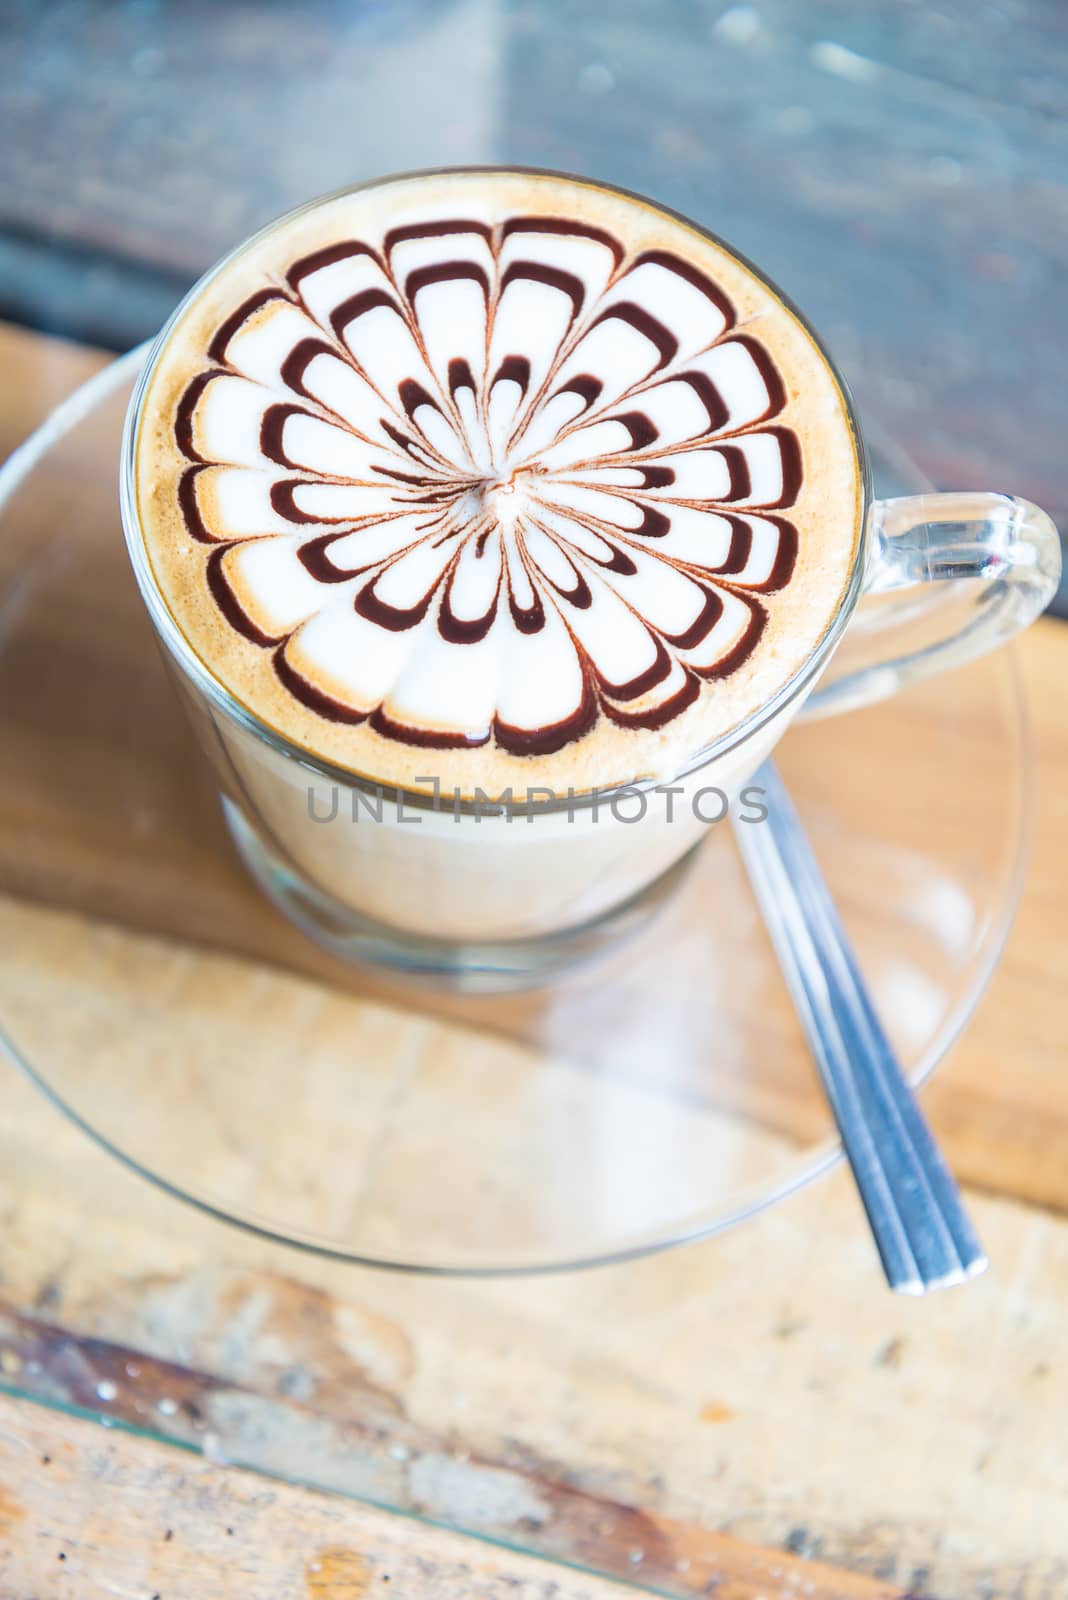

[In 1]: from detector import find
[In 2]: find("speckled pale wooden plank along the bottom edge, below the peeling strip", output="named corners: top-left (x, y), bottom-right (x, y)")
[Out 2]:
top-left (0, 1395), bottom-right (902, 1600)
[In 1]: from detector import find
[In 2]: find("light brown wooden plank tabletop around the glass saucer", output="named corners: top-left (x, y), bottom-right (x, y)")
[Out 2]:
top-left (0, 318), bottom-right (1068, 1600)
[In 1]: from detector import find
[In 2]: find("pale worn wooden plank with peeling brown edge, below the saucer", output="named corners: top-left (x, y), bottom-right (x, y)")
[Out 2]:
top-left (0, 1064), bottom-right (1068, 1600)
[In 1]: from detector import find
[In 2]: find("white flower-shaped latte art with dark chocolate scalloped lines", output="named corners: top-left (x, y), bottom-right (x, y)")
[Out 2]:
top-left (176, 216), bottom-right (801, 754)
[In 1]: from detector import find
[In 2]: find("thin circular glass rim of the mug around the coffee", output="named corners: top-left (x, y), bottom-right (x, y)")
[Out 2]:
top-left (118, 163), bottom-right (873, 816)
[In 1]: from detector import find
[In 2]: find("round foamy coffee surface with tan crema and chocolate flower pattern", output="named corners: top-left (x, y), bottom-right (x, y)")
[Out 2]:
top-left (136, 170), bottom-right (860, 794)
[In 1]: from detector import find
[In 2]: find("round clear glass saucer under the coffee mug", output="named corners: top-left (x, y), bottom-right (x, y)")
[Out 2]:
top-left (0, 352), bottom-right (1031, 1274)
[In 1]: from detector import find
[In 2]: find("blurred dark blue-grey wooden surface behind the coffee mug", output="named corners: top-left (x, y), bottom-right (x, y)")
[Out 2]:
top-left (0, 0), bottom-right (1068, 614)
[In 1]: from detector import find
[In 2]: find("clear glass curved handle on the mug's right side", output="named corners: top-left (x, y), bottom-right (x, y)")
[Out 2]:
top-left (801, 493), bottom-right (1060, 717)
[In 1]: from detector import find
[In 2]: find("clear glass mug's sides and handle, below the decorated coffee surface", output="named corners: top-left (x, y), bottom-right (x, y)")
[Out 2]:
top-left (120, 175), bottom-right (1060, 989)
